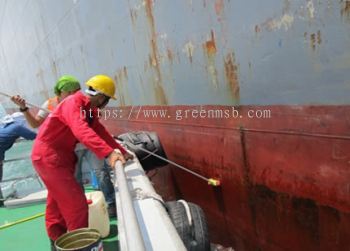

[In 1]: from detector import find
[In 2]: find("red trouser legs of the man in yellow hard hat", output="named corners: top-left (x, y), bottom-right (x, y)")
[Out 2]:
top-left (32, 155), bottom-right (88, 240)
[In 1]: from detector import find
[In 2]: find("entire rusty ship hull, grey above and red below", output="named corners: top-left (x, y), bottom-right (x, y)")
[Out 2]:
top-left (0, 0), bottom-right (350, 250)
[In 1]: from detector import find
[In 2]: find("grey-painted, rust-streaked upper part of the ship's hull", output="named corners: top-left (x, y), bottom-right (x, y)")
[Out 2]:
top-left (0, 0), bottom-right (350, 105)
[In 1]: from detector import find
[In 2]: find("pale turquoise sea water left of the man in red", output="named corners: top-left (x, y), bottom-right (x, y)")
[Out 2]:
top-left (1, 140), bottom-right (45, 198)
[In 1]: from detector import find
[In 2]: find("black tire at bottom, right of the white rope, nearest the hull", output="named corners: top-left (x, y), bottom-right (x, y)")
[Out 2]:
top-left (188, 202), bottom-right (210, 251)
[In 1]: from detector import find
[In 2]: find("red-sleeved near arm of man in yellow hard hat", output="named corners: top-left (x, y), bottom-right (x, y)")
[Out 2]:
top-left (57, 98), bottom-right (124, 158)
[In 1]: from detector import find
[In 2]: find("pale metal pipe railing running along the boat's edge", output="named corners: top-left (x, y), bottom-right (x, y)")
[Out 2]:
top-left (114, 161), bottom-right (146, 251)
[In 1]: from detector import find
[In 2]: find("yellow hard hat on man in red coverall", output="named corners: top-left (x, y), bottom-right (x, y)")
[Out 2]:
top-left (86, 75), bottom-right (116, 99)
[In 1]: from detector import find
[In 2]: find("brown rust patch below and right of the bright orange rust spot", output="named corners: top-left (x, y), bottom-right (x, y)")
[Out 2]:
top-left (224, 52), bottom-right (239, 100)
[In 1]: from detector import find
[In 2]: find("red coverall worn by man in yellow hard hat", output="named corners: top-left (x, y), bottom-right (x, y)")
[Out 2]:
top-left (32, 92), bottom-right (126, 240)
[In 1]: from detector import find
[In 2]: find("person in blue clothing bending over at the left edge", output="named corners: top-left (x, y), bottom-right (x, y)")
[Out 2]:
top-left (0, 112), bottom-right (36, 206)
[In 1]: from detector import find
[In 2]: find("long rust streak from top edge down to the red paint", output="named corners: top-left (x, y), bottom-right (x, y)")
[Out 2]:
top-left (145, 0), bottom-right (168, 105)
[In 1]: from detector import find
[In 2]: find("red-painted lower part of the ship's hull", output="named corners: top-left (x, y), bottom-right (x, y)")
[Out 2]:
top-left (105, 106), bottom-right (350, 250)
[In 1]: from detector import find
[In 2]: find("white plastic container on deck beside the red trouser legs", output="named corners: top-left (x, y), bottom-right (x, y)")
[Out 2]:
top-left (86, 191), bottom-right (110, 238)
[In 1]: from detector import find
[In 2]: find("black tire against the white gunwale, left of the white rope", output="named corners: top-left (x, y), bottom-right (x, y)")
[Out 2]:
top-left (165, 201), bottom-right (192, 249)
